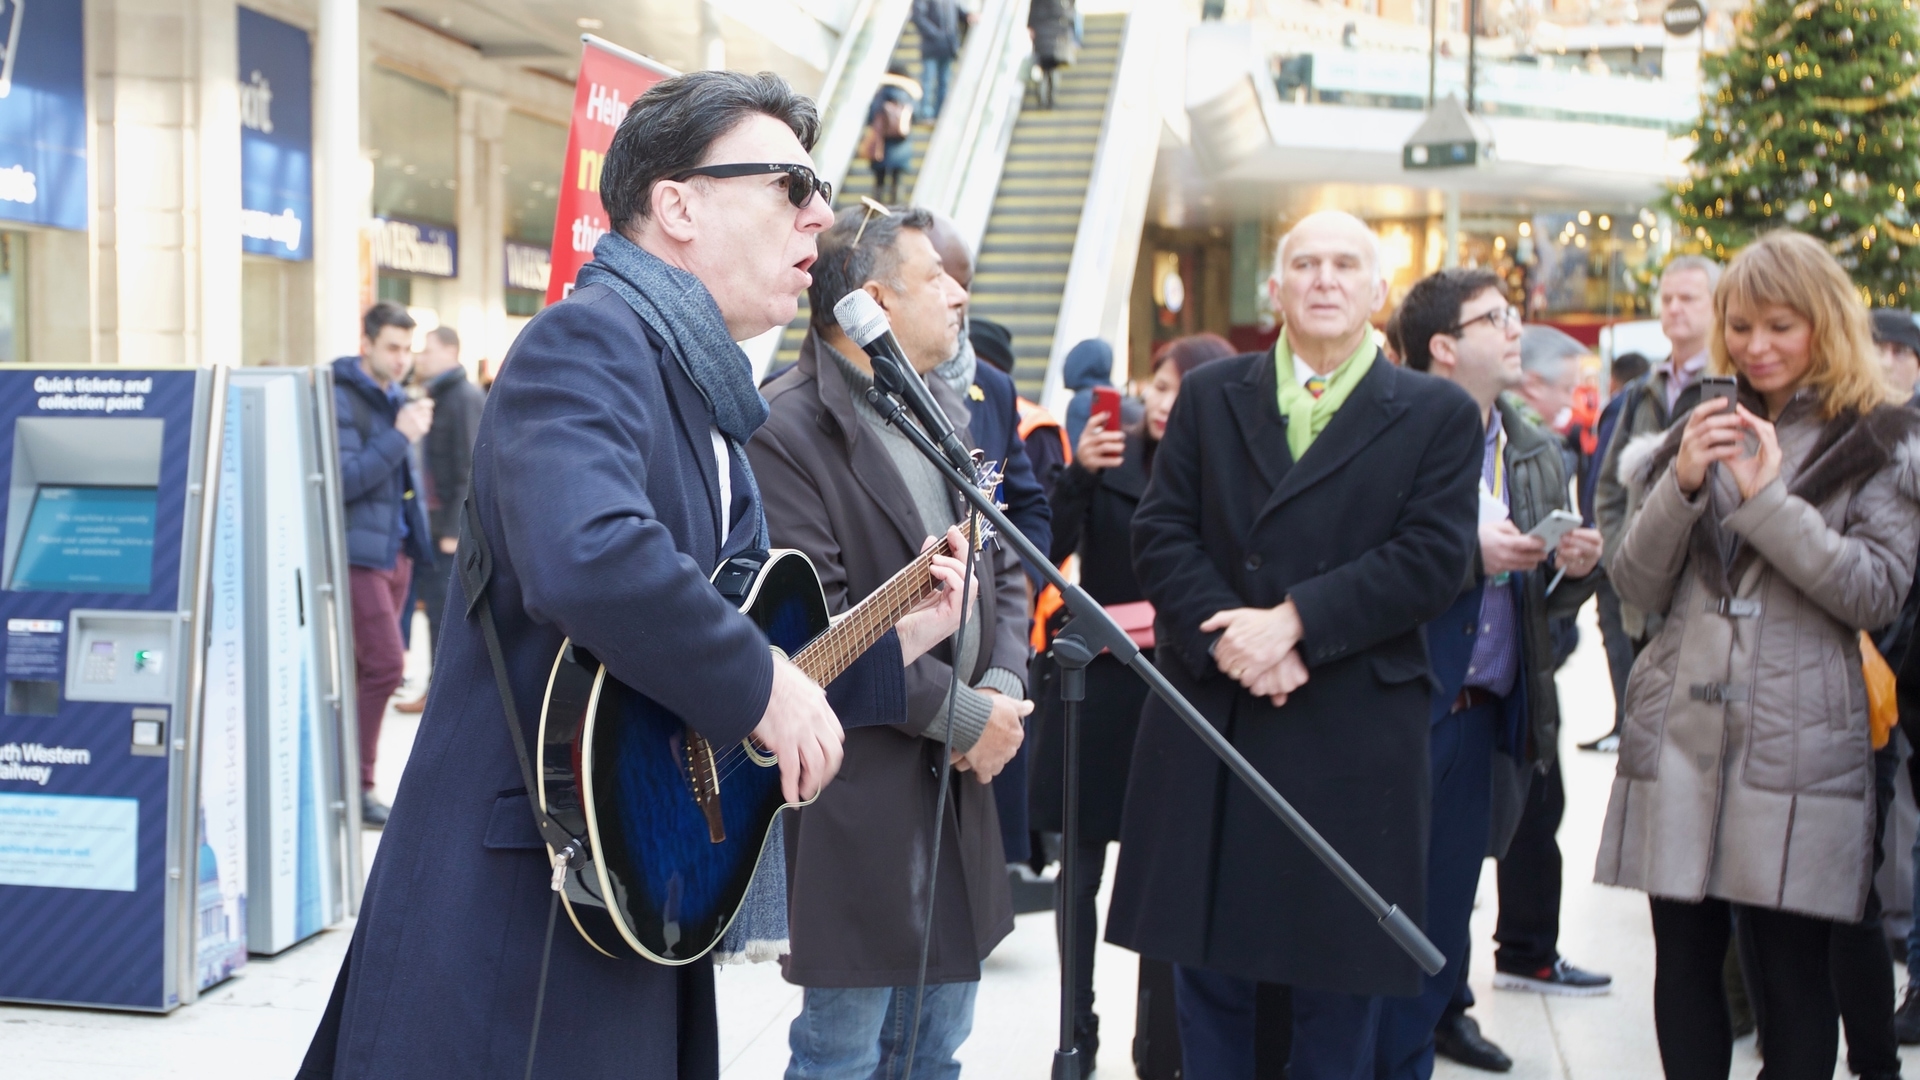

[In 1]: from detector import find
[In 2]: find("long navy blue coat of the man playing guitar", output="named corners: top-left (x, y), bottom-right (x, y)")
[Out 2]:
top-left (300, 286), bottom-right (906, 1080)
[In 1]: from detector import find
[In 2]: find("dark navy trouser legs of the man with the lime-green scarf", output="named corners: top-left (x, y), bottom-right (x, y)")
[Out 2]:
top-left (1173, 965), bottom-right (1382, 1080)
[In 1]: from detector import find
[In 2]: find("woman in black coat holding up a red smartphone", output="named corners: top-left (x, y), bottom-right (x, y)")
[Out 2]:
top-left (1029, 334), bottom-right (1235, 1070)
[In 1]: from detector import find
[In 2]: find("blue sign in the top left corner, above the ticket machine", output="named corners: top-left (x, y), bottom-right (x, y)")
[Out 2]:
top-left (0, 0), bottom-right (86, 229)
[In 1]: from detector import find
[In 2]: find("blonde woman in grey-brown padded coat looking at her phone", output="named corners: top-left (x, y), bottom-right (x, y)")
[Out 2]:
top-left (1596, 231), bottom-right (1920, 1080)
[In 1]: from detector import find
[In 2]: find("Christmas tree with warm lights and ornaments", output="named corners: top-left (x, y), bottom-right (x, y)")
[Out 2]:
top-left (1672, 0), bottom-right (1920, 307)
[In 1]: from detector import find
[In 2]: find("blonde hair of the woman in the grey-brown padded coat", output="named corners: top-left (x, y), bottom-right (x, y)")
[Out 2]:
top-left (1709, 229), bottom-right (1895, 419)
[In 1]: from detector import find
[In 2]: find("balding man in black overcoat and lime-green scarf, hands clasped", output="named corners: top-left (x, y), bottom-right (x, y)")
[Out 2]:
top-left (1108, 211), bottom-right (1480, 1080)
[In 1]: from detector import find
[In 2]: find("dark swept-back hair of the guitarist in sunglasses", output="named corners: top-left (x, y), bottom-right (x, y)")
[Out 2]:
top-left (601, 71), bottom-right (820, 233)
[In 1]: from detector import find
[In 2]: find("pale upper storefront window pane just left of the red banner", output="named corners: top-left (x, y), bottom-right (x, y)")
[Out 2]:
top-left (367, 67), bottom-right (459, 225)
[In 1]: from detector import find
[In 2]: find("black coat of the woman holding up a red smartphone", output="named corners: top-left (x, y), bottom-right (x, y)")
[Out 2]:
top-left (1029, 434), bottom-right (1148, 842)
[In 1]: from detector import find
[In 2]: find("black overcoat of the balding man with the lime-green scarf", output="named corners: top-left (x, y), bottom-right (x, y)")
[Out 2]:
top-left (1108, 354), bottom-right (1482, 994)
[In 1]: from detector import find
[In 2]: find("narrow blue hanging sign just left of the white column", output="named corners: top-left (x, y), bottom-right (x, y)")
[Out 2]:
top-left (241, 8), bottom-right (313, 259)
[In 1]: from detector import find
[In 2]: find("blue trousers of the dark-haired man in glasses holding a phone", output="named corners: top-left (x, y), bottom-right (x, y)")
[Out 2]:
top-left (1375, 700), bottom-right (1501, 1080)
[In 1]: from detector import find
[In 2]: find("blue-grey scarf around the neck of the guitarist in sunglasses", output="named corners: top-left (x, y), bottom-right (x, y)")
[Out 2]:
top-left (574, 233), bottom-right (787, 963)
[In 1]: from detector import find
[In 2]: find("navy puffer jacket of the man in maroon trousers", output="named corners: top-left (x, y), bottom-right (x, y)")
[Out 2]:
top-left (334, 356), bottom-right (434, 571)
